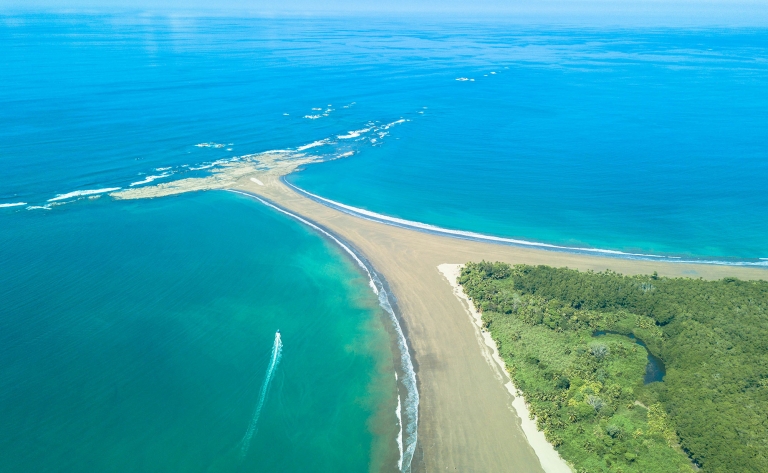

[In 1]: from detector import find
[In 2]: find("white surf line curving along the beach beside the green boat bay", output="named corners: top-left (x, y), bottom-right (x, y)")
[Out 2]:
top-left (228, 189), bottom-right (419, 473)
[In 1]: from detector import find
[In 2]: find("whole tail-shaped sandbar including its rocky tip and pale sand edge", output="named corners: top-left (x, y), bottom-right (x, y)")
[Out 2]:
top-left (110, 162), bottom-right (768, 473)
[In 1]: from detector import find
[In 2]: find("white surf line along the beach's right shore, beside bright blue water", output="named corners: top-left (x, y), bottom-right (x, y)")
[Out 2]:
top-left (280, 176), bottom-right (768, 266)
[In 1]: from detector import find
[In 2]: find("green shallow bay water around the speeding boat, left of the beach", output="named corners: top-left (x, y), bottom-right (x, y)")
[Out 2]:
top-left (0, 192), bottom-right (397, 472)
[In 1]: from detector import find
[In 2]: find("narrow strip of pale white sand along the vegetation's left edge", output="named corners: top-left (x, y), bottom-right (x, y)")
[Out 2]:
top-left (437, 264), bottom-right (572, 473)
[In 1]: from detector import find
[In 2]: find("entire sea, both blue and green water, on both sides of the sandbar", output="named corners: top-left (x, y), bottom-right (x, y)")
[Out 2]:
top-left (0, 13), bottom-right (768, 472)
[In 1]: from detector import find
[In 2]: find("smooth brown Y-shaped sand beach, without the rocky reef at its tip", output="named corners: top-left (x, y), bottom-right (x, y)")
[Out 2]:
top-left (222, 173), bottom-right (768, 473)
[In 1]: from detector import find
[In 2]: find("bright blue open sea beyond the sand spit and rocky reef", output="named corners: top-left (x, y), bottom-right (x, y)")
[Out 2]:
top-left (0, 15), bottom-right (768, 259)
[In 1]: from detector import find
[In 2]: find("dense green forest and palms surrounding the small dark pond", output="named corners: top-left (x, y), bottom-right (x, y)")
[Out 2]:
top-left (459, 262), bottom-right (768, 473)
